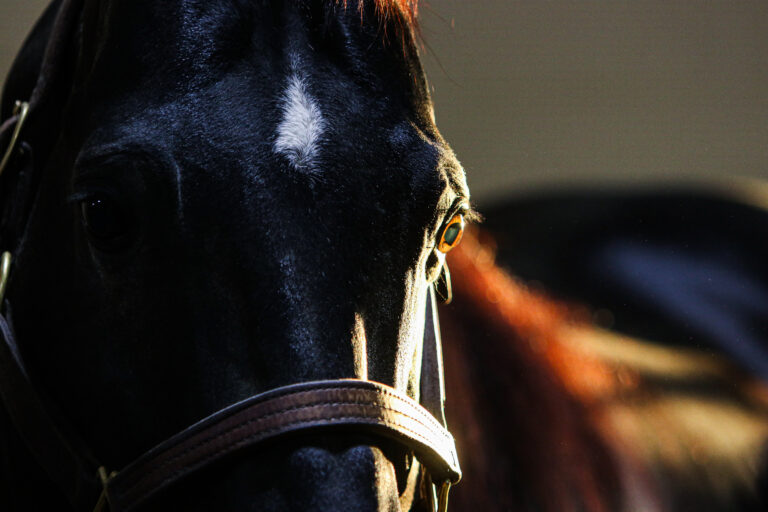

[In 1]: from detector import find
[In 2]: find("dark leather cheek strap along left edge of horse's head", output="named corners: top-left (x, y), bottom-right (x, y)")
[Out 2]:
top-left (0, 0), bottom-right (100, 508)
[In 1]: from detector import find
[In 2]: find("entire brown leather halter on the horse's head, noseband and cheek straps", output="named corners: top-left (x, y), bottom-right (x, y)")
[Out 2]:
top-left (0, 0), bottom-right (461, 512)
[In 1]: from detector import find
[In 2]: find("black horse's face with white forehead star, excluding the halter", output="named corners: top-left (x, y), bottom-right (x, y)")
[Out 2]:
top-left (9, 0), bottom-right (468, 510)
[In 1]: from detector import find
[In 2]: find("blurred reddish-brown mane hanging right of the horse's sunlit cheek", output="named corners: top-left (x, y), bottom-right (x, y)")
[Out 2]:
top-left (440, 232), bottom-right (620, 512)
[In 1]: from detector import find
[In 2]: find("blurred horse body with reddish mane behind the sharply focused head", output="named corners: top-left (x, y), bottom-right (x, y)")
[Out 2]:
top-left (441, 193), bottom-right (768, 512)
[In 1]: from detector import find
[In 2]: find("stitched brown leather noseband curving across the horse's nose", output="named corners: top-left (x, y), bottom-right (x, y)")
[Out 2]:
top-left (107, 380), bottom-right (461, 512)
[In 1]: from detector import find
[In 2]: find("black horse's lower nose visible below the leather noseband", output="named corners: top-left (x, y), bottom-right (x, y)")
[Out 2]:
top-left (142, 437), bottom-right (411, 512)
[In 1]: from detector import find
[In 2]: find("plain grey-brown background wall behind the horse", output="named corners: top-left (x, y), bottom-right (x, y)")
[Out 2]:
top-left (0, 0), bottom-right (768, 203)
